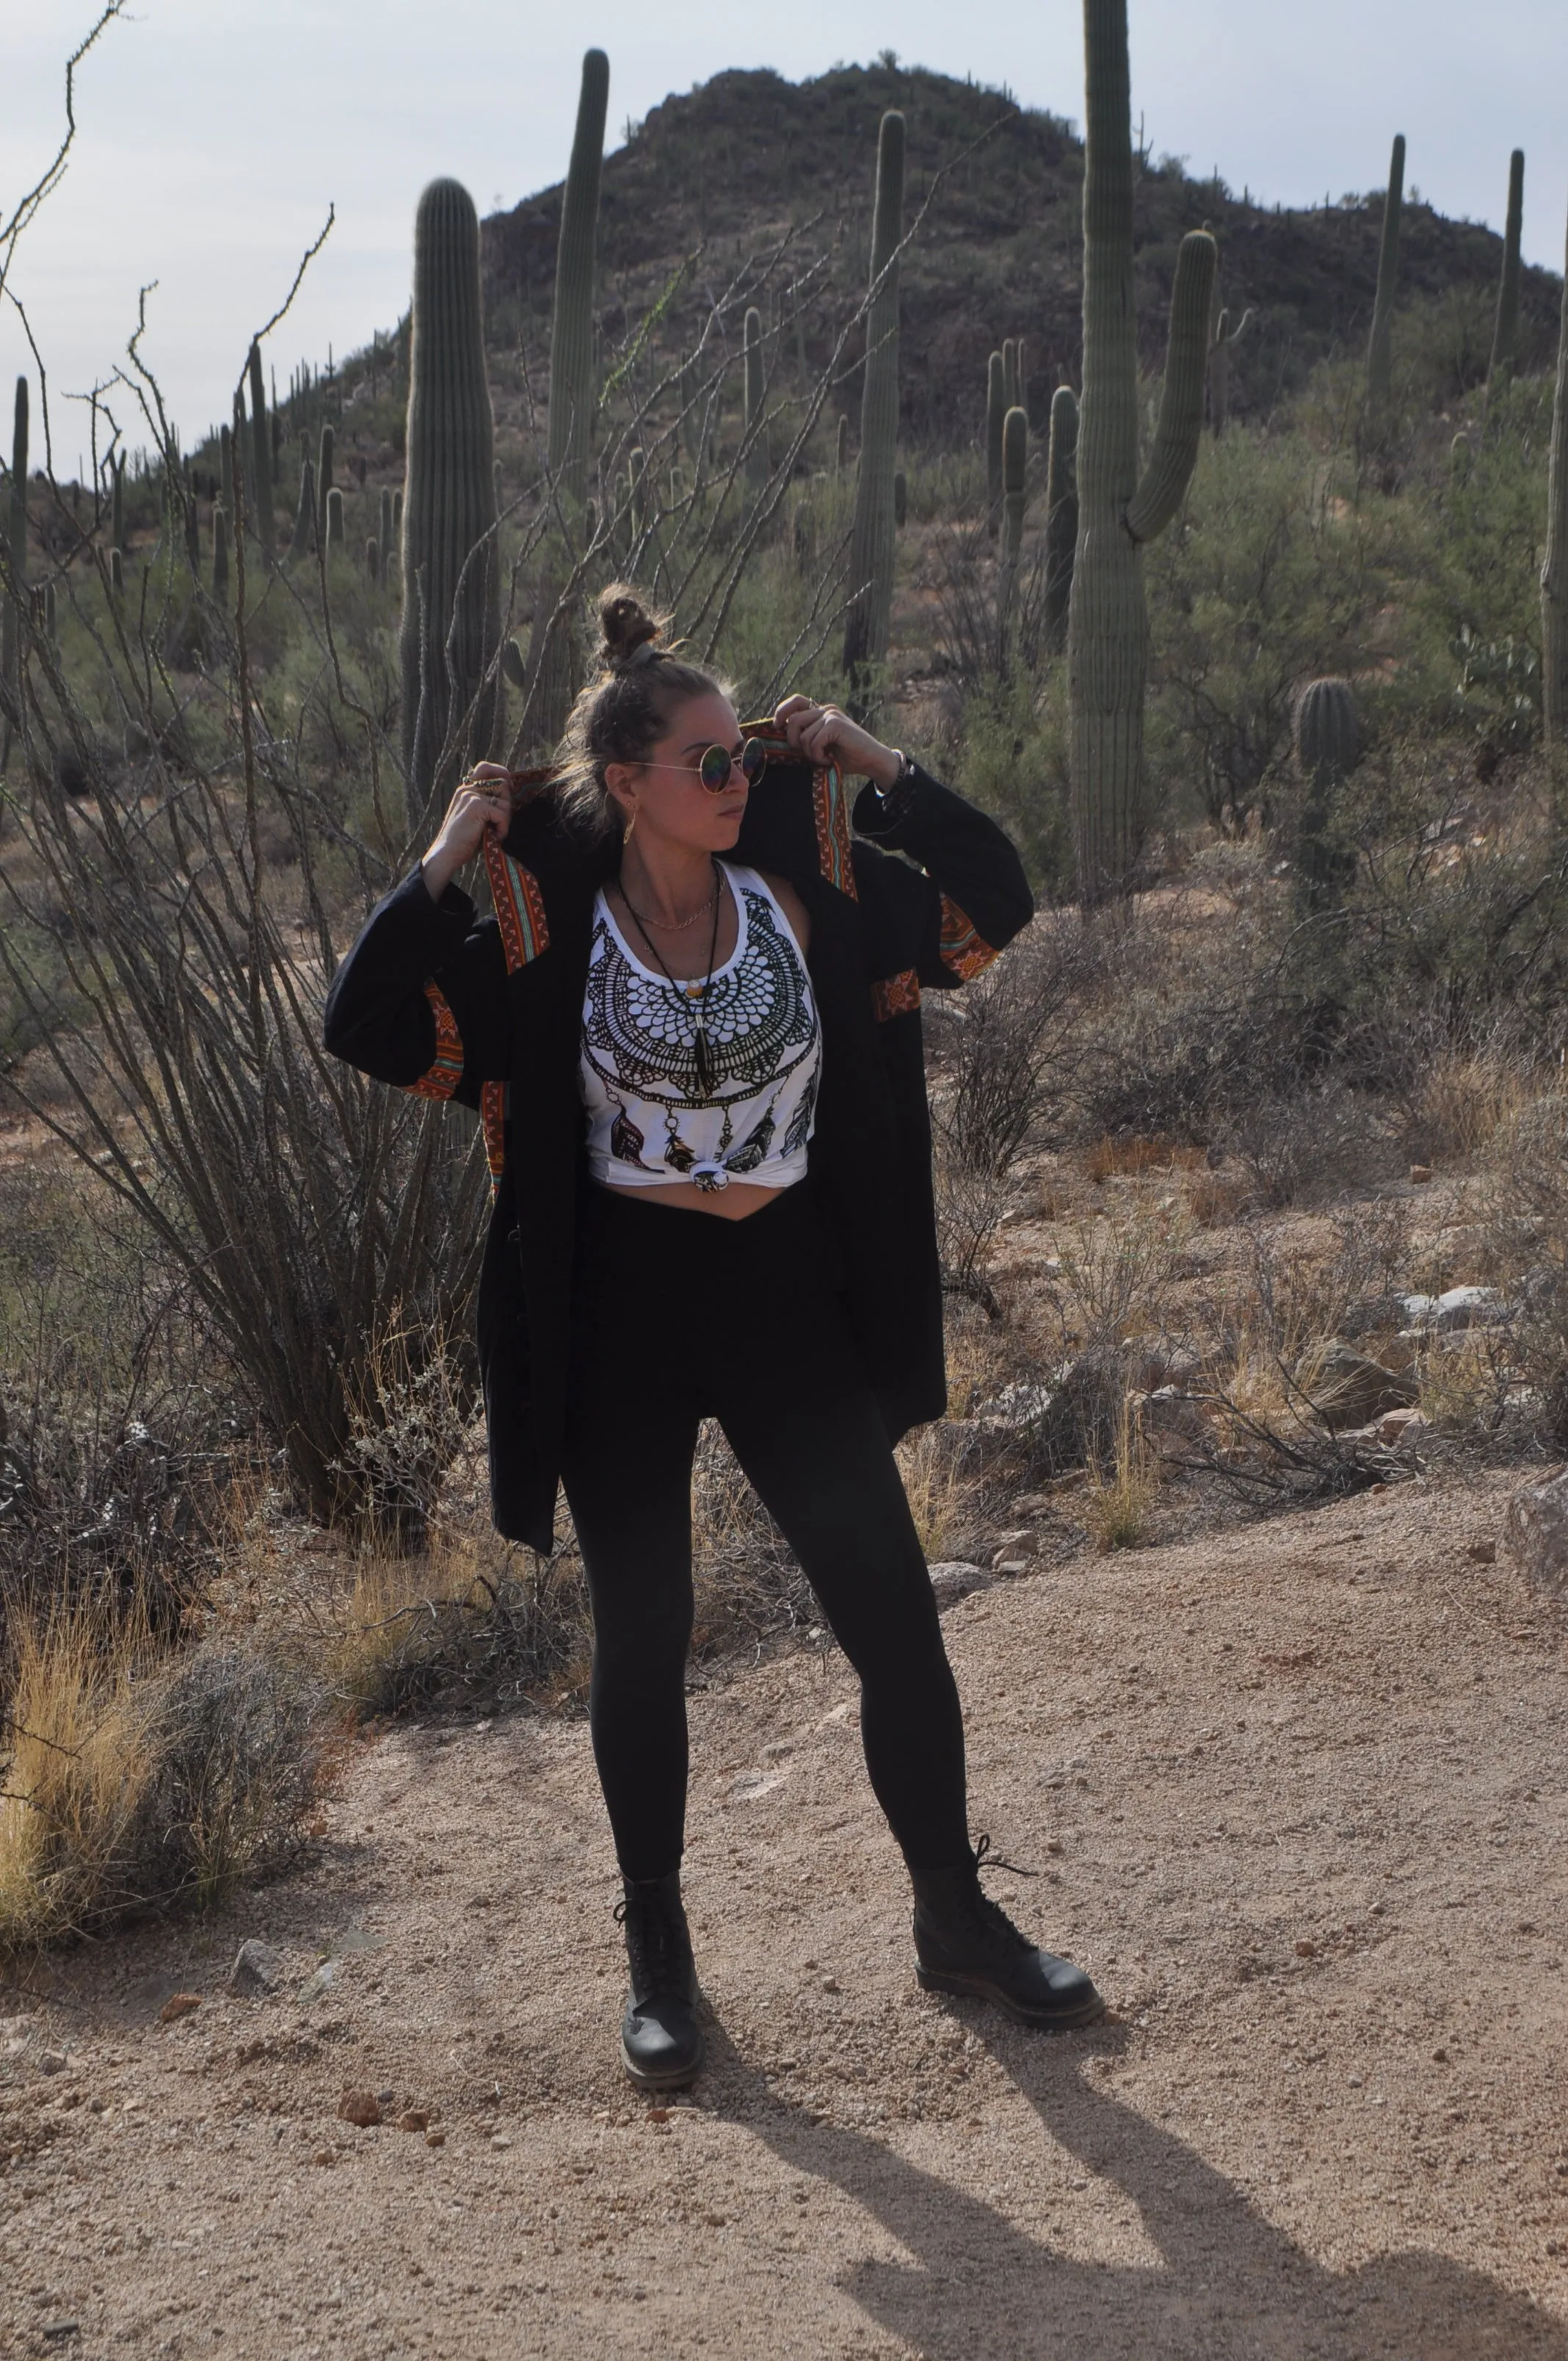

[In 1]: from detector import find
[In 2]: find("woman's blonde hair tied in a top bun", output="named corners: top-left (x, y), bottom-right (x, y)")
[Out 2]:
top-left (555, 583), bottom-right (732, 838)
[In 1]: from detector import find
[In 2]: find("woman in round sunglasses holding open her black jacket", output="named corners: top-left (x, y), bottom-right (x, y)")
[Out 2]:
top-left (326, 588), bottom-right (1100, 2089)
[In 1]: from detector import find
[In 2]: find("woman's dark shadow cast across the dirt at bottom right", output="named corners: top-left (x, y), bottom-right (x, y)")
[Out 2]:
top-left (708, 2009), bottom-right (1568, 2361)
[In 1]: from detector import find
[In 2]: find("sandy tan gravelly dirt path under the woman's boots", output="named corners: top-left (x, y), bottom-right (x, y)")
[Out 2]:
top-left (0, 1485), bottom-right (1568, 2361)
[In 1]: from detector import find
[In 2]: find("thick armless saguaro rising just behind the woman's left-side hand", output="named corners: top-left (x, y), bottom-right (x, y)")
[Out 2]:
top-left (399, 179), bottom-right (501, 829)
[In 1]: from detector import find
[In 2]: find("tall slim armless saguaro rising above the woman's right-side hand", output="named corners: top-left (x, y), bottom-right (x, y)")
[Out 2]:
top-left (843, 111), bottom-right (904, 703)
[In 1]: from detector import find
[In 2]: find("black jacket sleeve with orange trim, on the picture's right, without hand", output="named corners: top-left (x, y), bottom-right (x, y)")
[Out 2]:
top-left (855, 763), bottom-right (1034, 992)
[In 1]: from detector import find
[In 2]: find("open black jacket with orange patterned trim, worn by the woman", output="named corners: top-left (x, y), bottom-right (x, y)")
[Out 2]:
top-left (326, 732), bottom-right (1034, 1551)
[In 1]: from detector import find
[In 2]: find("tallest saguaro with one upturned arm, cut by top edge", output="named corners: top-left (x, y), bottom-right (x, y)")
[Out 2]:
top-left (1067, 0), bottom-right (1219, 902)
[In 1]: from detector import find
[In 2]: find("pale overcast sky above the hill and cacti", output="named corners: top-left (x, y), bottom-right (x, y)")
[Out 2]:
top-left (0, 0), bottom-right (1568, 474)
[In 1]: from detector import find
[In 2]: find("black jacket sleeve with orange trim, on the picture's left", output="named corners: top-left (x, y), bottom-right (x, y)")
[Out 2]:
top-left (324, 868), bottom-right (510, 1107)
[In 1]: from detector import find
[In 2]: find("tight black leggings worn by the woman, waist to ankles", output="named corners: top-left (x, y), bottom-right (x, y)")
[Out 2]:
top-left (562, 1183), bottom-right (968, 1877)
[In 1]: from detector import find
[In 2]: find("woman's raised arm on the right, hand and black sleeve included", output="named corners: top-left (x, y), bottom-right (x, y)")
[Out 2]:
top-left (774, 697), bottom-right (1034, 990)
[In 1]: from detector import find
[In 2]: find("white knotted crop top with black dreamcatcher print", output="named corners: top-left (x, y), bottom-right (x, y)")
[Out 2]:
top-left (578, 862), bottom-right (821, 1190)
